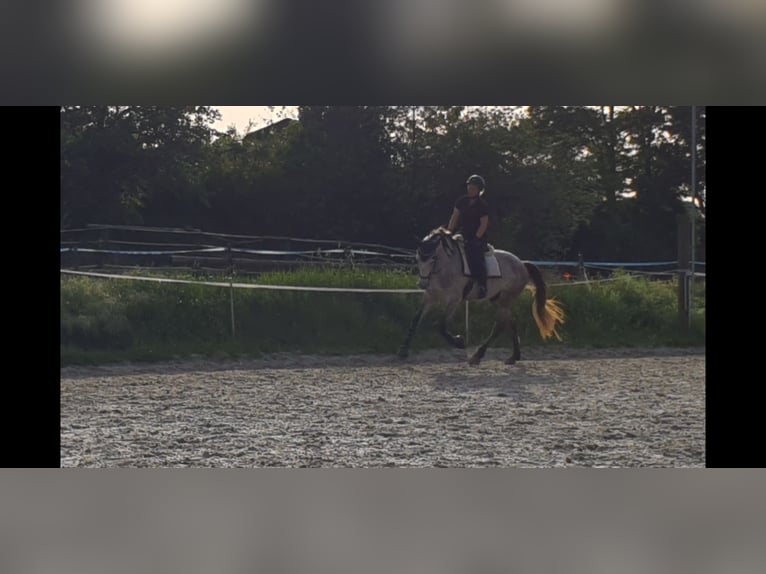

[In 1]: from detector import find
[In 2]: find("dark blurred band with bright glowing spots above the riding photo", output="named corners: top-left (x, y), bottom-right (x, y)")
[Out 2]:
top-left (0, 0), bottom-right (766, 104)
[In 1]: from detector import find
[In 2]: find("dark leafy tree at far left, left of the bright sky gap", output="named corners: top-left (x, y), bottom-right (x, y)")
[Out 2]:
top-left (61, 106), bottom-right (219, 226)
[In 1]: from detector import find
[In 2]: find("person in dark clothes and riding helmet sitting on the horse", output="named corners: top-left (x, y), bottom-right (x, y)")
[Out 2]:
top-left (447, 175), bottom-right (489, 299)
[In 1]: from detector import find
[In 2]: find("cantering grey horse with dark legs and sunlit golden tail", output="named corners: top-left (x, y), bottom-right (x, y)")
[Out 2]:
top-left (398, 227), bottom-right (565, 365)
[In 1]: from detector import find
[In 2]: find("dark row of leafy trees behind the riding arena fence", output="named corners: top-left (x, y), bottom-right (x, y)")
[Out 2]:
top-left (60, 106), bottom-right (706, 261)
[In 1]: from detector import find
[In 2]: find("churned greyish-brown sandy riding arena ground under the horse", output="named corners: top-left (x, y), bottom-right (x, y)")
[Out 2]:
top-left (61, 348), bottom-right (705, 468)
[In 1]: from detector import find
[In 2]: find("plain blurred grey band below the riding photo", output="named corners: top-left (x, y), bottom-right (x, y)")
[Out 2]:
top-left (0, 469), bottom-right (766, 574)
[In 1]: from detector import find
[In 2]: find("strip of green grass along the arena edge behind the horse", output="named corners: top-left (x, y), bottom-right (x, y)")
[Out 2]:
top-left (61, 268), bottom-right (705, 365)
